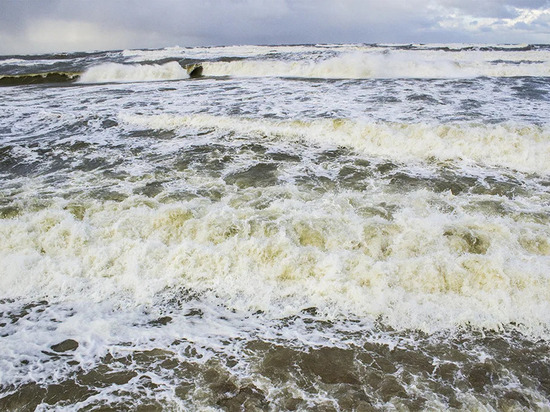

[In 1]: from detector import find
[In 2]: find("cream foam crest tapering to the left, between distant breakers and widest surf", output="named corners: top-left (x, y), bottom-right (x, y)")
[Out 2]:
top-left (121, 114), bottom-right (550, 174)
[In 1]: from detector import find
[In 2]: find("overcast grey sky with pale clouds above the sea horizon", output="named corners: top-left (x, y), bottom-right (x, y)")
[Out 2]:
top-left (0, 0), bottom-right (550, 55)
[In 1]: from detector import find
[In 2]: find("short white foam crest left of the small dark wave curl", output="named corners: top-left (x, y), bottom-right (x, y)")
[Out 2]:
top-left (78, 62), bottom-right (189, 83)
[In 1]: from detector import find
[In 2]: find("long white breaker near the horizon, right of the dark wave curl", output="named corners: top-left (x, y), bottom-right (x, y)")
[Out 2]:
top-left (204, 51), bottom-right (550, 79)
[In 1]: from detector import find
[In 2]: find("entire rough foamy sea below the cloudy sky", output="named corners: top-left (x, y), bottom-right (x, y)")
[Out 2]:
top-left (0, 45), bottom-right (550, 411)
